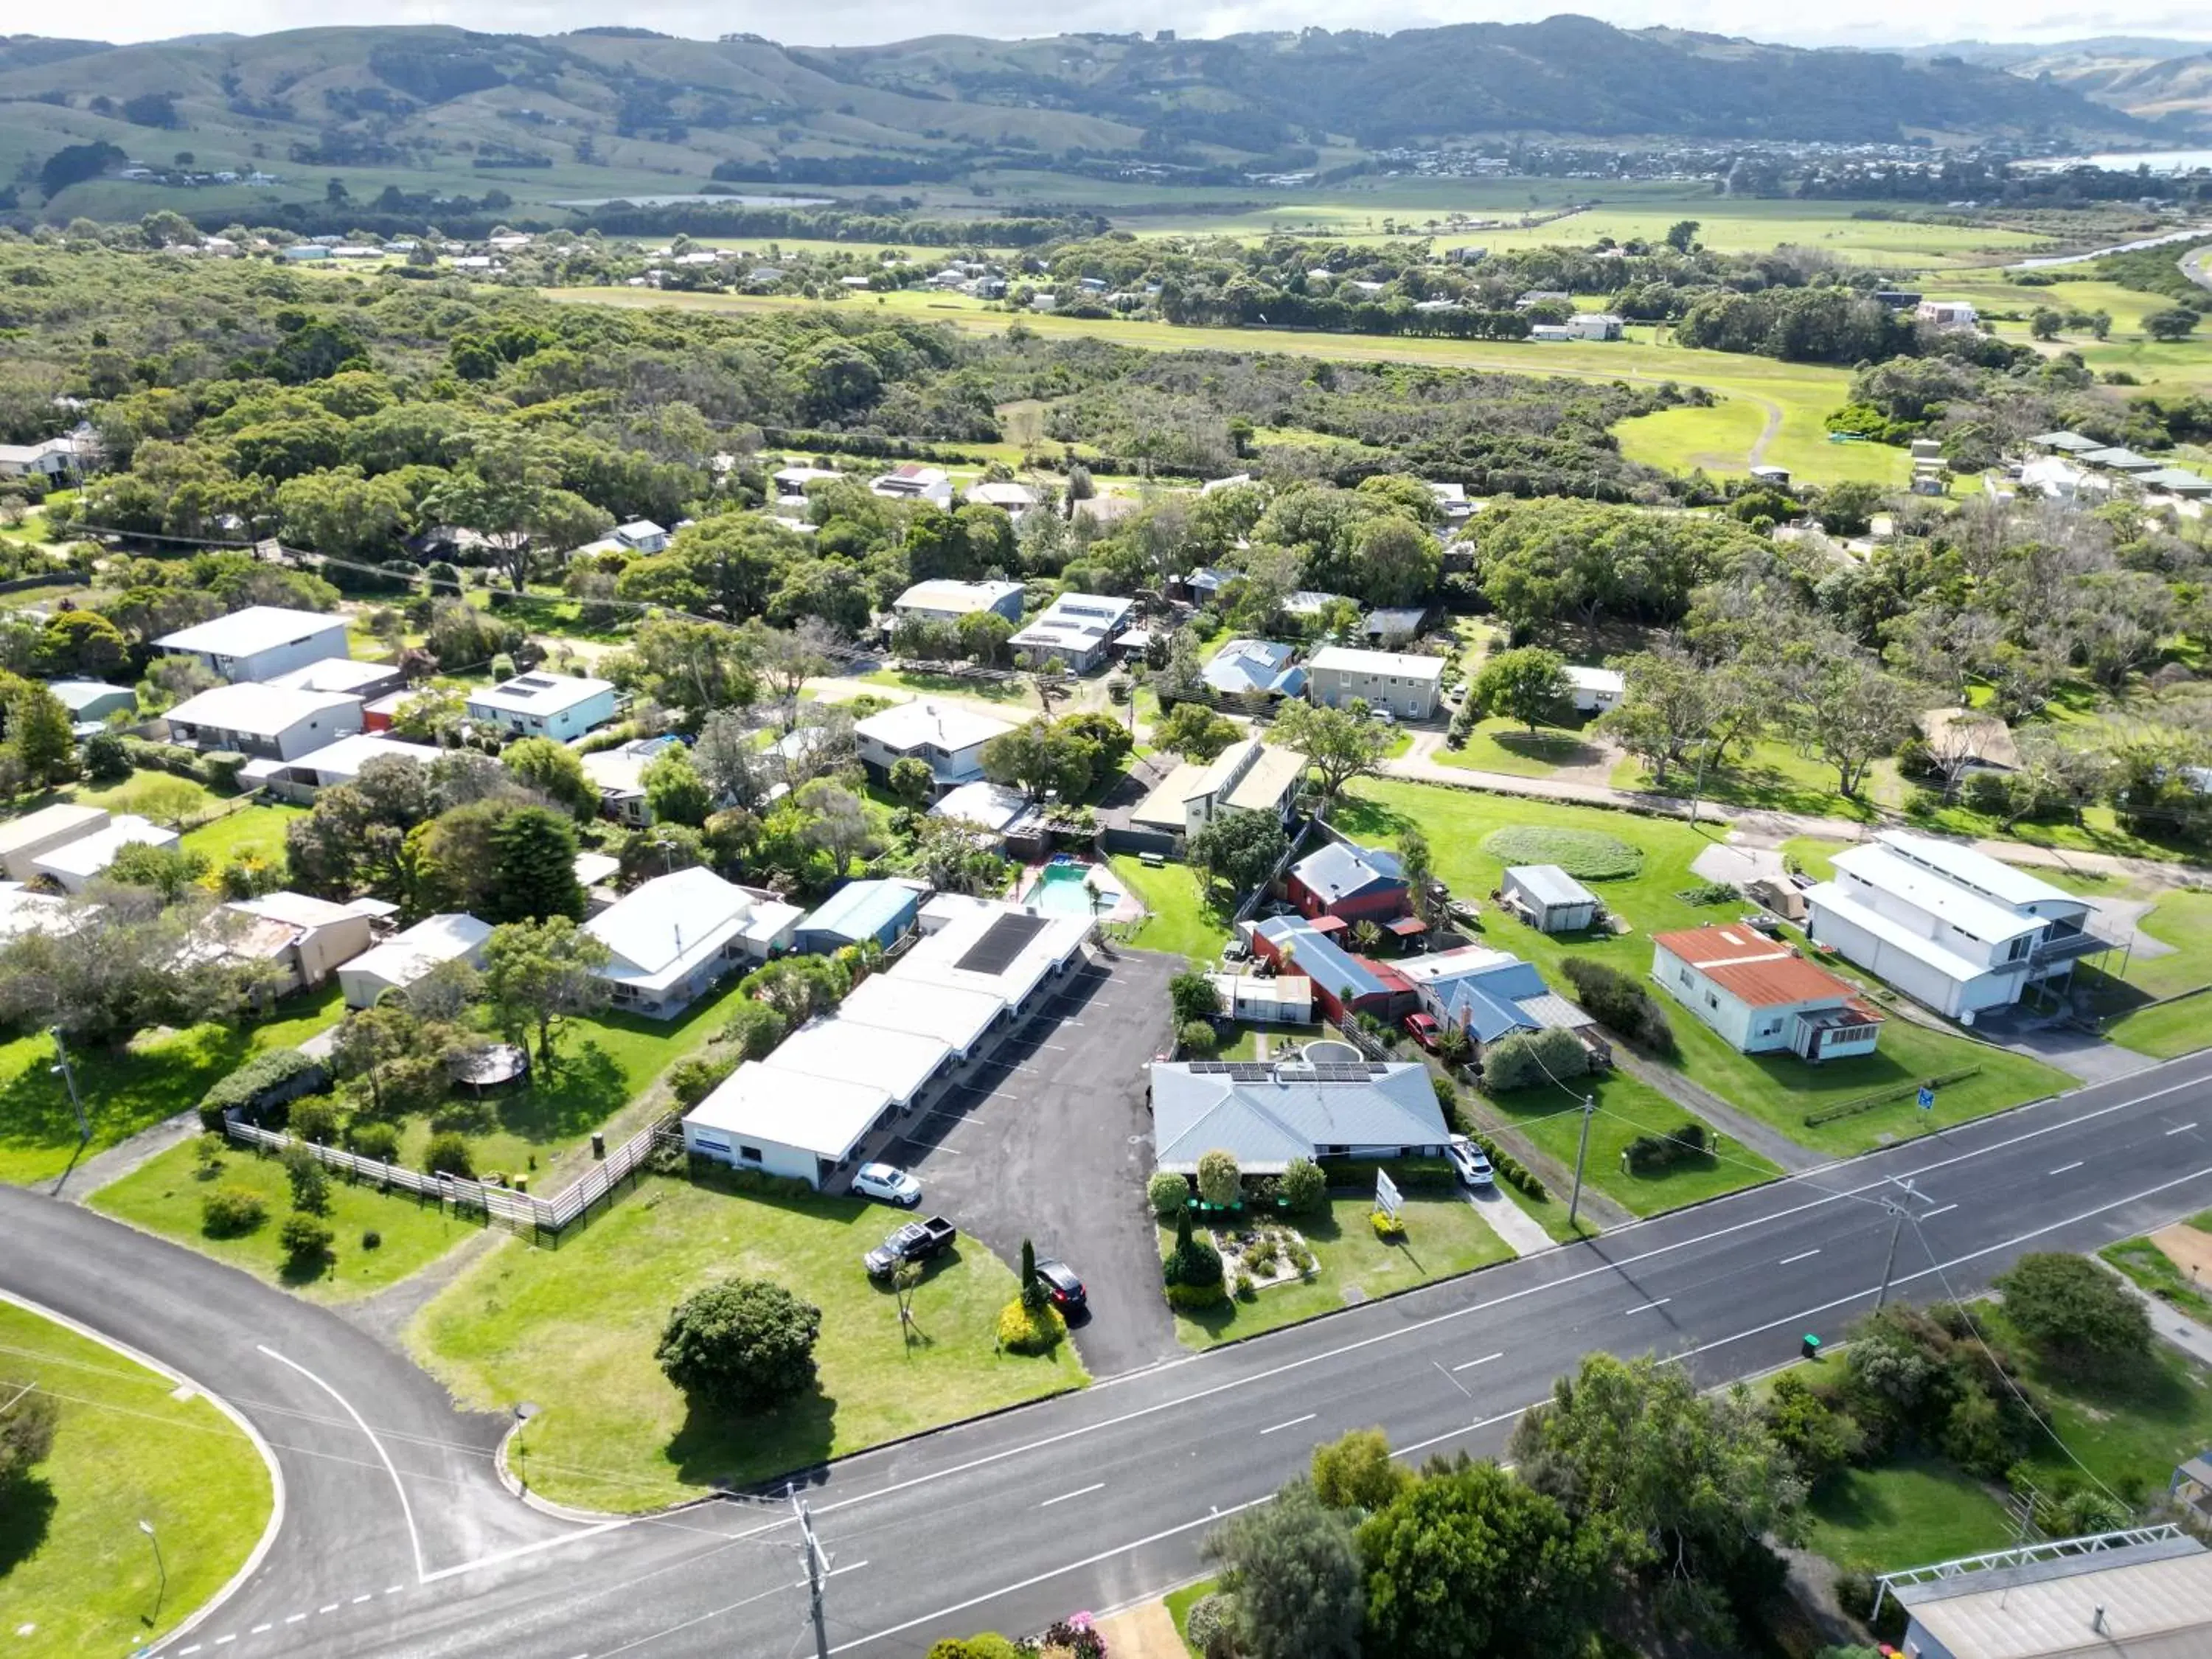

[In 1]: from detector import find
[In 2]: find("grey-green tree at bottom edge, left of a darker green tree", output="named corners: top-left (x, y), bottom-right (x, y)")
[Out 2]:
top-left (1206, 1480), bottom-right (1367, 1659)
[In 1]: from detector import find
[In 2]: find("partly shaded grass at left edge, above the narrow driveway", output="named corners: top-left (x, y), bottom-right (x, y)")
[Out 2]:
top-left (0, 984), bottom-right (338, 1183)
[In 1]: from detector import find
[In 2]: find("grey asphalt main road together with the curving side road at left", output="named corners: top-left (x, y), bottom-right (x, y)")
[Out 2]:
top-left (13, 1053), bottom-right (2212, 1659)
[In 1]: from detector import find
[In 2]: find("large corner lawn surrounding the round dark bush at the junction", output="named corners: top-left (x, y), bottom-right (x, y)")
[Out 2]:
top-left (407, 1179), bottom-right (1086, 1511)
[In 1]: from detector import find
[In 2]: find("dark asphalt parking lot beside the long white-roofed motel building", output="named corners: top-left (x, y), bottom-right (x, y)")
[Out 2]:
top-left (887, 951), bottom-right (1183, 1378)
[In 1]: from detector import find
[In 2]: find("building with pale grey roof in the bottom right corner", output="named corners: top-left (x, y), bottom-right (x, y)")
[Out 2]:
top-left (1876, 1524), bottom-right (2212, 1659)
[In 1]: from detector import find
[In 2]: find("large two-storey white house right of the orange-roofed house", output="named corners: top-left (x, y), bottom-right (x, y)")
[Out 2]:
top-left (1805, 830), bottom-right (2112, 1024)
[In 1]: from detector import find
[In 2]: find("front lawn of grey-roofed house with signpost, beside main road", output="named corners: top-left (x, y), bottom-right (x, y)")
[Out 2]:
top-left (1159, 1190), bottom-right (1513, 1347)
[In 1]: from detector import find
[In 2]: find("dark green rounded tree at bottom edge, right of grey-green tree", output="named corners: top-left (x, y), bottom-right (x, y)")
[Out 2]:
top-left (1354, 1460), bottom-right (1604, 1659)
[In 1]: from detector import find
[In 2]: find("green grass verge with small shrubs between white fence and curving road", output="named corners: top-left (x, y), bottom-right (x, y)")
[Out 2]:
top-left (91, 1141), bottom-right (482, 1303)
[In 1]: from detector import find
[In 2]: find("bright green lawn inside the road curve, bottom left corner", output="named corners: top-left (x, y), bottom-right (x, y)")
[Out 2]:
top-left (0, 1303), bottom-right (272, 1655)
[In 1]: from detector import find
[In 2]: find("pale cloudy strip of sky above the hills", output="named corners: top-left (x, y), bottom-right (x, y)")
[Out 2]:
top-left (47, 0), bottom-right (2212, 49)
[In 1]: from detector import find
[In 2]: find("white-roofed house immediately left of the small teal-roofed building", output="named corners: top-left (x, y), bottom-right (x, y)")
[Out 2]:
top-left (584, 867), bottom-right (801, 1020)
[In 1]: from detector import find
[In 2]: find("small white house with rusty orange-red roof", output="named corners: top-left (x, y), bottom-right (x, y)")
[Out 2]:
top-left (1652, 922), bottom-right (1882, 1064)
